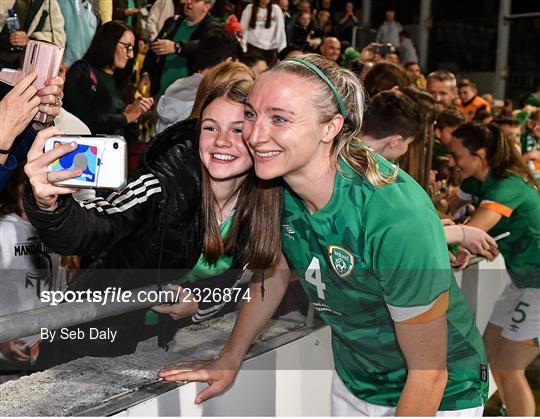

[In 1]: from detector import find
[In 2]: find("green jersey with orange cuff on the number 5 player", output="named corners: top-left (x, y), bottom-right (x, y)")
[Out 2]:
top-left (460, 174), bottom-right (540, 288)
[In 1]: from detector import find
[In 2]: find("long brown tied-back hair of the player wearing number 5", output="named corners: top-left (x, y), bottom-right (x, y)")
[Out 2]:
top-left (452, 122), bottom-right (539, 190)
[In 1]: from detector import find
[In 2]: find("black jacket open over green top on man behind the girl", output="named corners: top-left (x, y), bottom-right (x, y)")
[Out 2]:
top-left (141, 15), bottom-right (220, 95)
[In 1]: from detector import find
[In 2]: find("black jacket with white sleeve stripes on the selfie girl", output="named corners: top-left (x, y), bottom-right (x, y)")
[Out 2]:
top-left (23, 120), bottom-right (248, 366)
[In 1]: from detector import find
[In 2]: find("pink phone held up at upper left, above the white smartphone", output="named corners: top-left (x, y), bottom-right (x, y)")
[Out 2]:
top-left (22, 41), bottom-right (64, 122)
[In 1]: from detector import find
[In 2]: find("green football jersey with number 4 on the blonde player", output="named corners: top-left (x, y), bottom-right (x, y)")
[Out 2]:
top-left (282, 156), bottom-right (488, 410)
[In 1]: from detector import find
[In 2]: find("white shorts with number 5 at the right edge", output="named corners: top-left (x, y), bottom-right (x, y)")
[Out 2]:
top-left (489, 284), bottom-right (540, 346)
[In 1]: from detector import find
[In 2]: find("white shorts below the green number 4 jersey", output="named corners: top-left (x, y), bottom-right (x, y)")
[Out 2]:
top-left (332, 371), bottom-right (484, 417)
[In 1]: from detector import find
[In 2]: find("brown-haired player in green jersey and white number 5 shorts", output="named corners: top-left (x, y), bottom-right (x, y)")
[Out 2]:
top-left (450, 123), bottom-right (540, 416)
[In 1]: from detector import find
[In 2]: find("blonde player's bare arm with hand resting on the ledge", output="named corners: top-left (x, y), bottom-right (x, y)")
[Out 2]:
top-left (158, 254), bottom-right (290, 404)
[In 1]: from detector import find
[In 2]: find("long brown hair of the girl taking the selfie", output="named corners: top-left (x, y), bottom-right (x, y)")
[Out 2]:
top-left (199, 80), bottom-right (282, 270)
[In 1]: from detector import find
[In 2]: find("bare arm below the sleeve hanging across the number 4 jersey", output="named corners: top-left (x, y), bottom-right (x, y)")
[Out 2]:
top-left (395, 314), bottom-right (448, 416)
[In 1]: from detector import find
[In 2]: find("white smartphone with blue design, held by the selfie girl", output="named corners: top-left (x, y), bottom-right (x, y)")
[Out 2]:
top-left (45, 135), bottom-right (127, 189)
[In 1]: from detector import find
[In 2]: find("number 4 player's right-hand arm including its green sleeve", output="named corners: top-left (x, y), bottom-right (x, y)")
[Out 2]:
top-left (366, 193), bottom-right (454, 416)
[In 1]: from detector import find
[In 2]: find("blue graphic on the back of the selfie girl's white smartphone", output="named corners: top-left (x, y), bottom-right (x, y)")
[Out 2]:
top-left (49, 141), bottom-right (98, 184)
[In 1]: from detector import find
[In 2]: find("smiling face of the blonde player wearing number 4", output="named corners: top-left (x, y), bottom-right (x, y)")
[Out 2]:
top-left (244, 72), bottom-right (331, 179)
